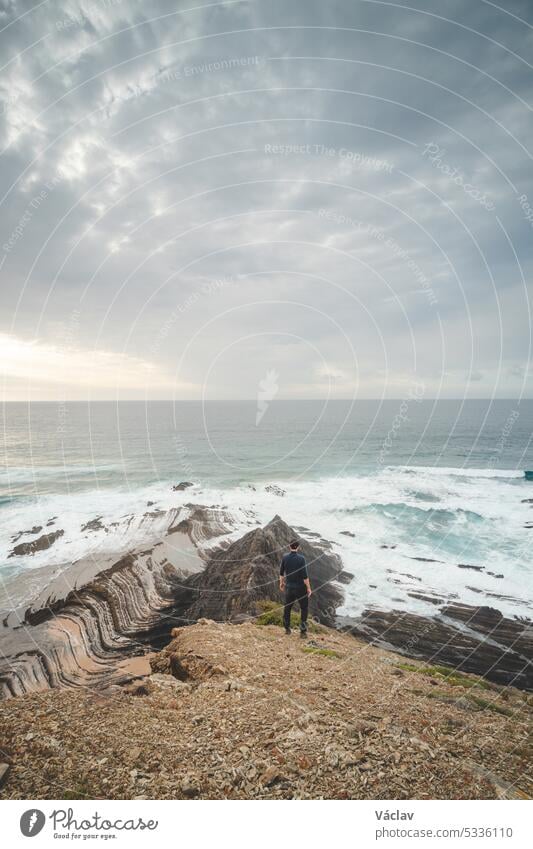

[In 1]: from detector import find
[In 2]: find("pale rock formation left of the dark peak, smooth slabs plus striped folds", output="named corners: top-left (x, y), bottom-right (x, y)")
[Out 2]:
top-left (0, 507), bottom-right (231, 698)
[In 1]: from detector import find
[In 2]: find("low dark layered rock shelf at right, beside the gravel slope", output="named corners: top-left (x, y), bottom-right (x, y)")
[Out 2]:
top-left (339, 603), bottom-right (533, 690)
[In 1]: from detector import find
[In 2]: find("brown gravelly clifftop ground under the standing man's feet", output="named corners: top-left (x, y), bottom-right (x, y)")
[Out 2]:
top-left (0, 620), bottom-right (533, 799)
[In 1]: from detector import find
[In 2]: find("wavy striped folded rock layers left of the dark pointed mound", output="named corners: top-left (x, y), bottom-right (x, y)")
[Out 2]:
top-left (0, 552), bottom-right (179, 698)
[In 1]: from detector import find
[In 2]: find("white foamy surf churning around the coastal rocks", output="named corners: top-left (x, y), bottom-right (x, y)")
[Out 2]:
top-left (0, 467), bottom-right (533, 616)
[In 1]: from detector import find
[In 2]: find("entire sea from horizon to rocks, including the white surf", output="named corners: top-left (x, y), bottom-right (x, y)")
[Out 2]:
top-left (0, 400), bottom-right (533, 618)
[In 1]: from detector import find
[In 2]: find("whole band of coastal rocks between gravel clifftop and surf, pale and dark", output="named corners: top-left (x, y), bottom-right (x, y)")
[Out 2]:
top-left (0, 504), bottom-right (533, 699)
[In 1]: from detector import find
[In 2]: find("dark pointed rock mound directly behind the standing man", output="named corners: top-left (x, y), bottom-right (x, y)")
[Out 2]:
top-left (172, 516), bottom-right (342, 625)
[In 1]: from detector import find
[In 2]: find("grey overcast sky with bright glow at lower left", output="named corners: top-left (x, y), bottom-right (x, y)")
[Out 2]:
top-left (0, 0), bottom-right (533, 400)
